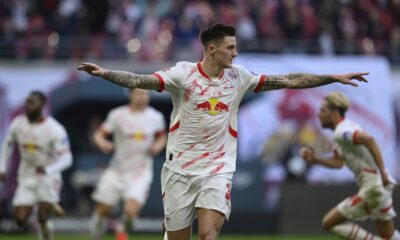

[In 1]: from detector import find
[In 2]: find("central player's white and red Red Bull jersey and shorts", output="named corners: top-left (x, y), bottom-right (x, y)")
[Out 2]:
top-left (154, 62), bottom-right (265, 231)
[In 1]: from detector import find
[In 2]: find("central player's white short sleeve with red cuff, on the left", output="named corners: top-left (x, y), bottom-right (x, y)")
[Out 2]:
top-left (153, 62), bottom-right (189, 92)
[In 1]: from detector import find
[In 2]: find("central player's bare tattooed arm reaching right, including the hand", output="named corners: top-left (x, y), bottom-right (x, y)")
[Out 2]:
top-left (260, 73), bottom-right (368, 91)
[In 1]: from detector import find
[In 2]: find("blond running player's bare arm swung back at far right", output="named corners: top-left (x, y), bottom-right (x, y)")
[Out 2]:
top-left (353, 131), bottom-right (391, 185)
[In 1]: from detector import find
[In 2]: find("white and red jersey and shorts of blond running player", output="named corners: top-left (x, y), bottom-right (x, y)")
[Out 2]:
top-left (334, 119), bottom-right (396, 220)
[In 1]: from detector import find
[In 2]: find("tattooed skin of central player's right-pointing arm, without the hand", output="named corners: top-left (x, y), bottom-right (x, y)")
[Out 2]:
top-left (262, 73), bottom-right (337, 91)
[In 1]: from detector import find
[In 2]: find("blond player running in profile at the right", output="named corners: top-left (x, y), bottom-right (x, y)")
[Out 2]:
top-left (300, 92), bottom-right (400, 240)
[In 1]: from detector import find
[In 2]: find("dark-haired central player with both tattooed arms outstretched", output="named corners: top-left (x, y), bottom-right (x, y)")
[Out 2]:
top-left (78, 24), bottom-right (366, 240)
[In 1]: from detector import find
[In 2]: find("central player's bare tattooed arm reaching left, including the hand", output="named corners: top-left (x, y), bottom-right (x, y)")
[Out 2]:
top-left (78, 63), bottom-right (160, 90)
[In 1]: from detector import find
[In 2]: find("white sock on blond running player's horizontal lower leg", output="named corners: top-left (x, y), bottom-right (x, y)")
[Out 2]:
top-left (330, 223), bottom-right (382, 240)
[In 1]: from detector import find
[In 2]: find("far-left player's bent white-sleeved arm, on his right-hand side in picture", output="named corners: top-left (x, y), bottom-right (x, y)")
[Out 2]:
top-left (43, 127), bottom-right (72, 174)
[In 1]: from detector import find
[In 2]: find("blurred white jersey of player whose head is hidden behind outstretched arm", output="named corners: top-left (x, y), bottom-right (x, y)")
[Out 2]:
top-left (101, 105), bottom-right (165, 173)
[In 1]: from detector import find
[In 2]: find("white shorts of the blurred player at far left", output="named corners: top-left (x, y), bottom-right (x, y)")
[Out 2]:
top-left (12, 174), bottom-right (62, 206)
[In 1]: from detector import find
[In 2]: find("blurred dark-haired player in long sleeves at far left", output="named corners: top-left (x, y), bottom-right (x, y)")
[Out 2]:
top-left (0, 91), bottom-right (72, 240)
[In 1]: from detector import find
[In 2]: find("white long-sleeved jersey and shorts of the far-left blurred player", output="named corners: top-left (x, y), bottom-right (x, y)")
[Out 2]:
top-left (0, 115), bottom-right (72, 206)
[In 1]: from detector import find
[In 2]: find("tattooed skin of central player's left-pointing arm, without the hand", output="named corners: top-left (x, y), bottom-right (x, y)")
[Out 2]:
top-left (103, 70), bottom-right (160, 90)
